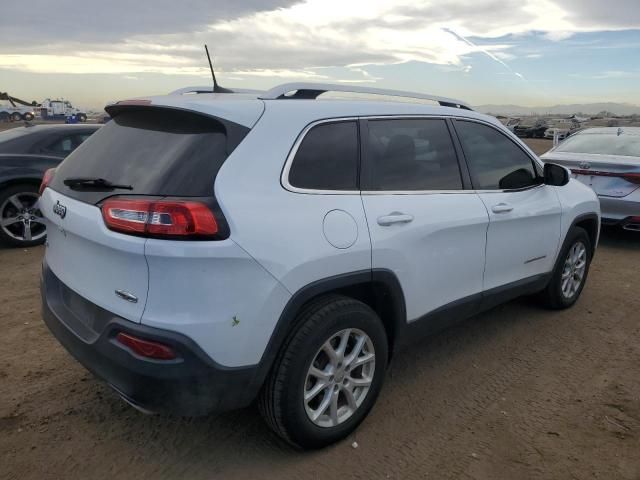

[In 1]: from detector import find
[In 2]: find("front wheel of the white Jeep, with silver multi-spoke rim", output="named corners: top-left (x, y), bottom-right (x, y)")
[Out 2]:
top-left (540, 227), bottom-right (592, 310)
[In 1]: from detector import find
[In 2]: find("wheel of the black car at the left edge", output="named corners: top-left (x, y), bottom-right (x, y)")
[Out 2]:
top-left (0, 184), bottom-right (47, 247)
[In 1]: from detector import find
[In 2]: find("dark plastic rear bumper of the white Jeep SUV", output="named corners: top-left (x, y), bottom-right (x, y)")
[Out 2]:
top-left (41, 263), bottom-right (261, 416)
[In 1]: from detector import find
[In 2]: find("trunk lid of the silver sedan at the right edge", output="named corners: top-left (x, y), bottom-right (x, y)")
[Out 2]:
top-left (542, 151), bottom-right (640, 197)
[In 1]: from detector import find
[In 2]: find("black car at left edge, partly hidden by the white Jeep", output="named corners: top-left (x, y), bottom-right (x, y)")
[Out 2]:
top-left (0, 124), bottom-right (100, 247)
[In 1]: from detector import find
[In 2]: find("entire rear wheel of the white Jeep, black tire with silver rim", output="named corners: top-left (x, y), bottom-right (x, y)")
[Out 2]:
top-left (258, 295), bottom-right (388, 448)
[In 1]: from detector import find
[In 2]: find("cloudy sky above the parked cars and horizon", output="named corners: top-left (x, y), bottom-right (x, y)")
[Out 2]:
top-left (0, 0), bottom-right (640, 109)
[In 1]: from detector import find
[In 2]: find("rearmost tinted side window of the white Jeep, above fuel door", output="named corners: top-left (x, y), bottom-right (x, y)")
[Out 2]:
top-left (289, 121), bottom-right (359, 190)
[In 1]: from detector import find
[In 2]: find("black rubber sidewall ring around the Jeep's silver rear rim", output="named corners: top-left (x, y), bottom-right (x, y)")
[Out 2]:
top-left (283, 304), bottom-right (388, 448)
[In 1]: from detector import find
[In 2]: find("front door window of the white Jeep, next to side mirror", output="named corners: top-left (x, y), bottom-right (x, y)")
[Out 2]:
top-left (456, 121), bottom-right (540, 190)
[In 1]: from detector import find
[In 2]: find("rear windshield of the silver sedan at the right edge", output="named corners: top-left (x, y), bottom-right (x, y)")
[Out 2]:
top-left (556, 133), bottom-right (640, 157)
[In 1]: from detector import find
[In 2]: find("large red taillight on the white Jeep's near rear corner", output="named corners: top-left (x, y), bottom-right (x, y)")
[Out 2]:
top-left (102, 198), bottom-right (218, 238)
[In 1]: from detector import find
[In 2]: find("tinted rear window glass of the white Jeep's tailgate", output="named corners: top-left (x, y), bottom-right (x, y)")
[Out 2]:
top-left (51, 108), bottom-right (249, 203)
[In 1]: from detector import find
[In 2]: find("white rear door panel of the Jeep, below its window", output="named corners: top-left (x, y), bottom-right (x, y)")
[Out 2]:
top-left (362, 191), bottom-right (488, 321)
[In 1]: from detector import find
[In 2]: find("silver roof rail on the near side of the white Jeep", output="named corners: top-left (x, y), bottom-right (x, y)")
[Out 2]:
top-left (260, 82), bottom-right (473, 110)
